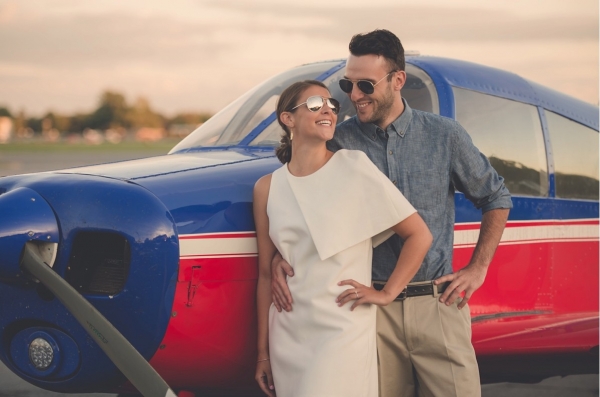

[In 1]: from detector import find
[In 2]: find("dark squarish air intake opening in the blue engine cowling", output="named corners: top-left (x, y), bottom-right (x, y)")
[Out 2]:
top-left (65, 232), bottom-right (131, 295)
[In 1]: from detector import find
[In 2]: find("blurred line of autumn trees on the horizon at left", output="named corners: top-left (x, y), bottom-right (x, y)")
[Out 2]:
top-left (0, 91), bottom-right (211, 133)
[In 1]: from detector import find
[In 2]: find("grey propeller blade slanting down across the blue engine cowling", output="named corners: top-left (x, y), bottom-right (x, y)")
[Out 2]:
top-left (21, 242), bottom-right (176, 397)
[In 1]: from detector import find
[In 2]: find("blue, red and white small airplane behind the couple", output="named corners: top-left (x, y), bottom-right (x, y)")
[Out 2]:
top-left (0, 53), bottom-right (599, 397)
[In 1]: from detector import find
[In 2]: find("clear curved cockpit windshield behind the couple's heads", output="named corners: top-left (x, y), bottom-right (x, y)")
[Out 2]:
top-left (169, 61), bottom-right (439, 153)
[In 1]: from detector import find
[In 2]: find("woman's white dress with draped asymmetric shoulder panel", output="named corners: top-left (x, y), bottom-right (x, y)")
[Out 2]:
top-left (267, 150), bottom-right (416, 397)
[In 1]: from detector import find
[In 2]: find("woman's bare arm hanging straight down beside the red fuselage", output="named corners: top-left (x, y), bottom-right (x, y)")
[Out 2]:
top-left (253, 174), bottom-right (276, 397)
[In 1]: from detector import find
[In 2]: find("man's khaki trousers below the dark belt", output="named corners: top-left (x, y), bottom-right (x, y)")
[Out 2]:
top-left (377, 296), bottom-right (481, 397)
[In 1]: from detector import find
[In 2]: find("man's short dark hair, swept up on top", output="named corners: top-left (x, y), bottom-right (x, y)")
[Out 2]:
top-left (348, 29), bottom-right (405, 71)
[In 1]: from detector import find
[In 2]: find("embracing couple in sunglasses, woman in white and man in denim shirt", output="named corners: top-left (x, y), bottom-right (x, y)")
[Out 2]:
top-left (254, 30), bottom-right (512, 397)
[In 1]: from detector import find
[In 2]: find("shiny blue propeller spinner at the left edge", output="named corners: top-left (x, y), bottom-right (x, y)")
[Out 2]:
top-left (0, 187), bottom-right (59, 283)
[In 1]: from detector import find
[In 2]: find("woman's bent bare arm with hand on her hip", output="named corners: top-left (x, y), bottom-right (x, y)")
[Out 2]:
top-left (336, 213), bottom-right (433, 310)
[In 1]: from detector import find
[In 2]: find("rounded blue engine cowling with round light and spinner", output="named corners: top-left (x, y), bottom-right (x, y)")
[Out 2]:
top-left (0, 173), bottom-right (179, 395)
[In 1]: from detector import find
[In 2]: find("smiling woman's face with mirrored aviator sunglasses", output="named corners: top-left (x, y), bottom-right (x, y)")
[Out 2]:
top-left (292, 85), bottom-right (337, 142)
